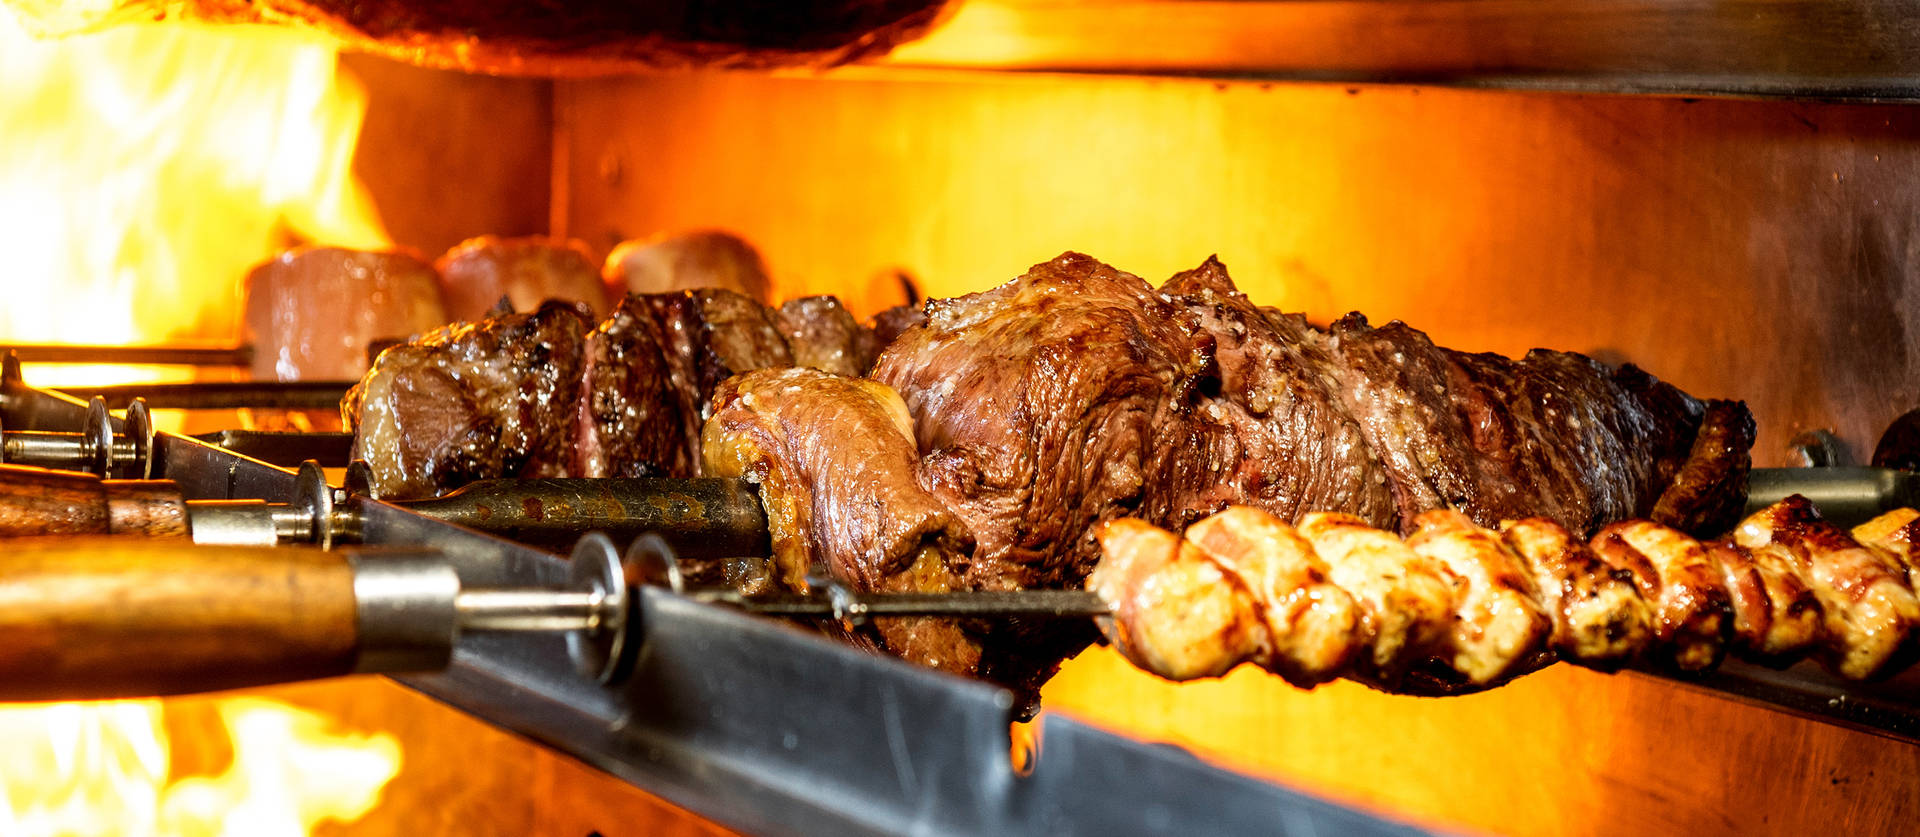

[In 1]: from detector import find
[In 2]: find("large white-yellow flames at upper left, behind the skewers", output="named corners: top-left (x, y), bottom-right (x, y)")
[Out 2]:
top-left (0, 10), bottom-right (388, 382)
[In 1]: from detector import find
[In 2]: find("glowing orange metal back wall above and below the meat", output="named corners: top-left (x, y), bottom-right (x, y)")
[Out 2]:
top-left (553, 71), bottom-right (1920, 833)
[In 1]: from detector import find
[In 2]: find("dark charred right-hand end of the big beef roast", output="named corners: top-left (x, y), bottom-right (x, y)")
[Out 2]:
top-left (1332, 315), bottom-right (1751, 536)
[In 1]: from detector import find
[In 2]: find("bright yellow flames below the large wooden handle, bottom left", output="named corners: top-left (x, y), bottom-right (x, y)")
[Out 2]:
top-left (0, 697), bottom-right (399, 837)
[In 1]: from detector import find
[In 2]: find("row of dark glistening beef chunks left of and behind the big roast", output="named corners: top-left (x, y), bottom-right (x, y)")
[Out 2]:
top-left (353, 288), bottom-right (890, 499)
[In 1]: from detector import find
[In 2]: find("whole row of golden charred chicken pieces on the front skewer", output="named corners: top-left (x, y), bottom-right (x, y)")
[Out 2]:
top-left (1087, 497), bottom-right (1920, 693)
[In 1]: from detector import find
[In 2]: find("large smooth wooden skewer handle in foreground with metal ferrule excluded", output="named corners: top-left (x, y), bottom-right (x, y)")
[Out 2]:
top-left (0, 538), bottom-right (359, 701)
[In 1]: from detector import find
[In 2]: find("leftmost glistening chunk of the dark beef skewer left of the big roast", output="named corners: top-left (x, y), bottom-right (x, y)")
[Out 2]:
top-left (340, 303), bottom-right (588, 497)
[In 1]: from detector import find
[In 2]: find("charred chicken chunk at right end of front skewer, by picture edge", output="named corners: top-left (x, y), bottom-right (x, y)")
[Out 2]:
top-left (1734, 495), bottom-right (1920, 680)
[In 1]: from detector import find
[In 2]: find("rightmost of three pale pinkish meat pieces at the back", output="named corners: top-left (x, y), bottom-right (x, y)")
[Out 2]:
top-left (603, 230), bottom-right (772, 303)
